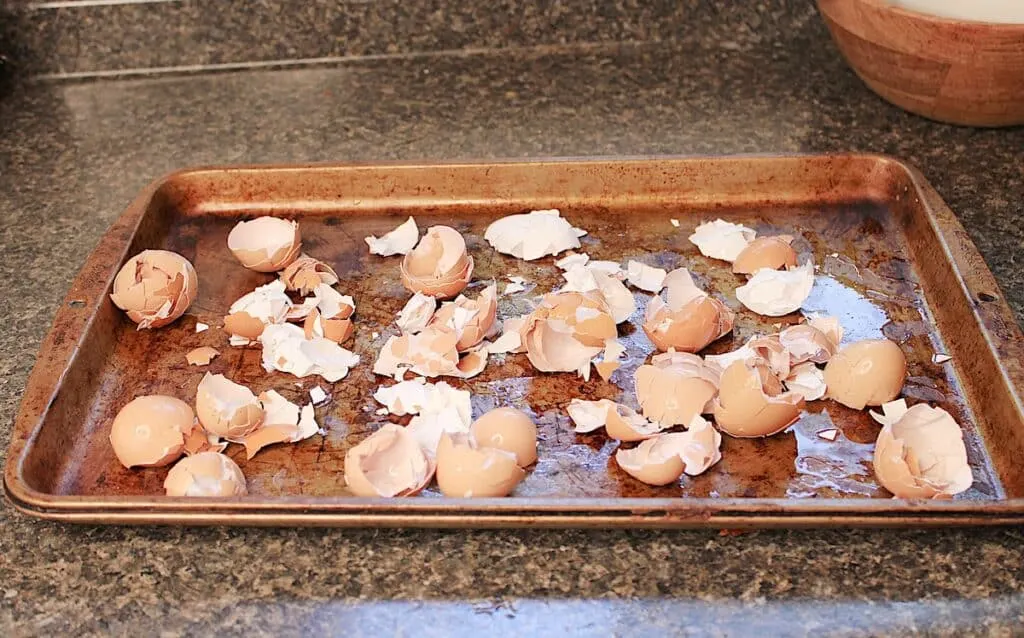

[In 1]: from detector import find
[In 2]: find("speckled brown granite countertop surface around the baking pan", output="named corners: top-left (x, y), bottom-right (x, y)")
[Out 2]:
top-left (0, 9), bottom-right (1024, 636)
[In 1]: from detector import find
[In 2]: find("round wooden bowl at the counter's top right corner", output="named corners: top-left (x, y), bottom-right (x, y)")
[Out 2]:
top-left (817, 0), bottom-right (1024, 126)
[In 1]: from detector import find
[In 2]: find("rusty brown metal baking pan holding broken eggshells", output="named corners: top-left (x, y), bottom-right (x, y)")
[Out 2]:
top-left (4, 155), bottom-right (1024, 527)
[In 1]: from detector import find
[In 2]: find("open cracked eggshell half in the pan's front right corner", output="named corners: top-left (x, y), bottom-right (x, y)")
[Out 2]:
top-left (872, 399), bottom-right (974, 499)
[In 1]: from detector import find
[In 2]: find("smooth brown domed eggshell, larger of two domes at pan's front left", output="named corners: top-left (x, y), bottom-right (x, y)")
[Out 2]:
top-left (110, 394), bottom-right (196, 467)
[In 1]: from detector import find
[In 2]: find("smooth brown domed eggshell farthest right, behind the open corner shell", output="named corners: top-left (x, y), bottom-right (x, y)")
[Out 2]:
top-left (824, 339), bottom-right (906, 410)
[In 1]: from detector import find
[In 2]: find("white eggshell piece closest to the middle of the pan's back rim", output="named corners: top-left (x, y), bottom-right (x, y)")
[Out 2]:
top-left (483, 209), bottom-right (587, 261)
